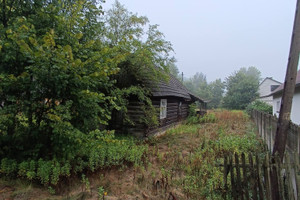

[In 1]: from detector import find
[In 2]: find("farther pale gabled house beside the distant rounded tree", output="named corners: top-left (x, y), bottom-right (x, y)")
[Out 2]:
top-left (258, 77), bottom-right (281, 105)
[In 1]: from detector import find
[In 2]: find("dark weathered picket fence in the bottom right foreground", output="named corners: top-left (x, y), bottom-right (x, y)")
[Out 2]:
top-left (223, 153), bottom-right (300, 200)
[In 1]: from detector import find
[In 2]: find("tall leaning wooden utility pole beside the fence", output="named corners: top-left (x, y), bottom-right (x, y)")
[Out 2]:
top-left (271, 0), bottom-right (300, 200)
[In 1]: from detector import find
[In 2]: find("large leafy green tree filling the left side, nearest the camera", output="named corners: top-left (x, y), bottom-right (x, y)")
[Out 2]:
top-left (0, 0), bottom-right (124, 159)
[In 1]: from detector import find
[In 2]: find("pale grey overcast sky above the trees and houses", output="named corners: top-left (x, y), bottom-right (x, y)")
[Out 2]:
top-left (103, 0), bottom-right (296, 82)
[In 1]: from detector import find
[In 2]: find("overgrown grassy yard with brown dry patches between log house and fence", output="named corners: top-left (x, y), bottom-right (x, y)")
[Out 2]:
top-left (0, 111), bottom-right (261, 200)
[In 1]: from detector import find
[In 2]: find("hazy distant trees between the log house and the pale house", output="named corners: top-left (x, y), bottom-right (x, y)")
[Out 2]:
top-left (180, 67), bottom-right (260, 110)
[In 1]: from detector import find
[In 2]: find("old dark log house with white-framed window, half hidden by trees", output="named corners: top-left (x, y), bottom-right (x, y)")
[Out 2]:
top-left (117, 75), bottom-right (206, 138)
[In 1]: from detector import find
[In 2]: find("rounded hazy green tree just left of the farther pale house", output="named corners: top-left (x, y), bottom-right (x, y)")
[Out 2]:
top-left (223, 67), bottom-right (261, 109)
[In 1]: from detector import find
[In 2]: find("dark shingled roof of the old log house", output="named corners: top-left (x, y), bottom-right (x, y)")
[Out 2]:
top-left (151, 75), bottom-right (204, 102)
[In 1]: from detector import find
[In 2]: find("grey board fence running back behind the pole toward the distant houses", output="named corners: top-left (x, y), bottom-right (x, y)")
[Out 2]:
top-left (251, 110), bottom-right (300, 155)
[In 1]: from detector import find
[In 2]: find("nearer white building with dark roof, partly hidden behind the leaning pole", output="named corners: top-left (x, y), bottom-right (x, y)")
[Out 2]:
top-left (272, 70), bottom-right (300, 124)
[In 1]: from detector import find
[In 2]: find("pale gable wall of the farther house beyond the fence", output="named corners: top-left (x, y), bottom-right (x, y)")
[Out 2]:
top-left (258, 78), bottom-right (280, 105)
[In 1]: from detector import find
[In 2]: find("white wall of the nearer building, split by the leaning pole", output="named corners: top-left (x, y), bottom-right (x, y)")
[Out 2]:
top-left (273, 88), bottom-right (300, 124)
